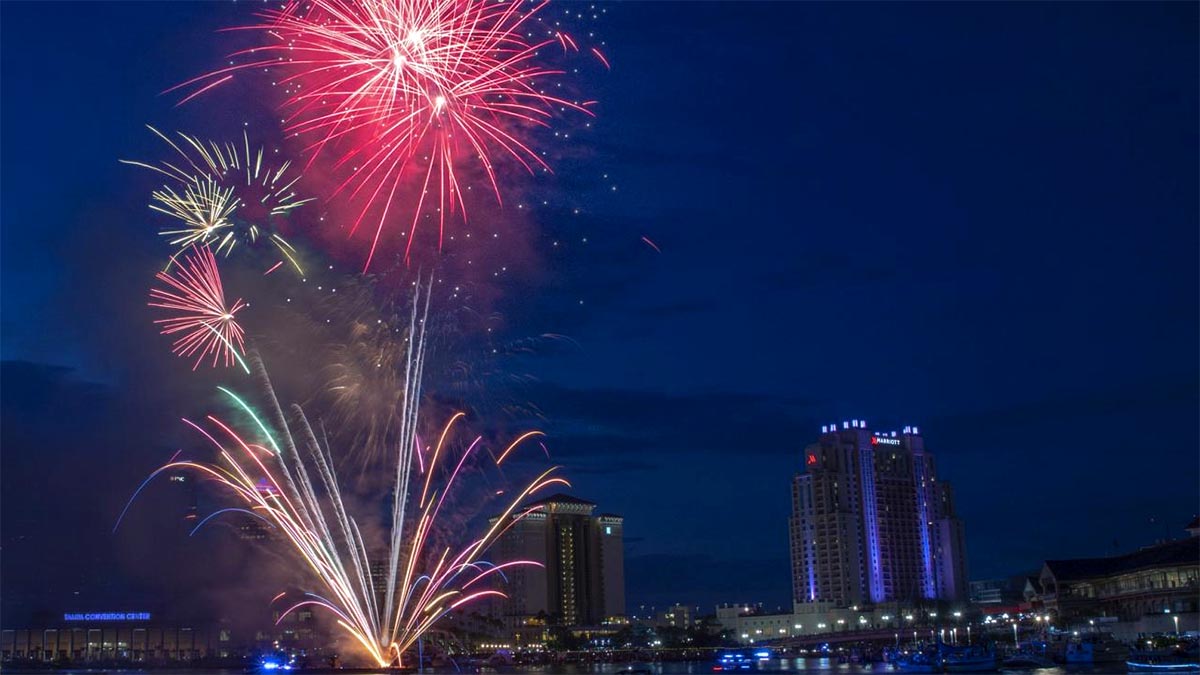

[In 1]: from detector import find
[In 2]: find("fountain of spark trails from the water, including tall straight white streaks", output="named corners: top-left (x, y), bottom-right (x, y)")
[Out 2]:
top-left (114, 282), bottom-right (568, 667)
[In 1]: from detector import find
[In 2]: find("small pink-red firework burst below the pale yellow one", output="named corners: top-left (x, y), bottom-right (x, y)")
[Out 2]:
top-left (150, 246), bottom-right (246, 370)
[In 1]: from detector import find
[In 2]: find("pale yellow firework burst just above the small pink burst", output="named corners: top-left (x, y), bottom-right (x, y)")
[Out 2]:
top-left (120, 126), bottom-right (313, 274)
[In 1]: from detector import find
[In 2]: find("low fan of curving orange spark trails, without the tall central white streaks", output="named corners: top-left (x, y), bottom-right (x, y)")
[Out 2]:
top-left (118, 359), bottom-right (566, 667)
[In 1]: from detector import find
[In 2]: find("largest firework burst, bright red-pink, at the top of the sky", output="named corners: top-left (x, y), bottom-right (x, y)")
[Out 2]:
top-left (180, 0), bottom-right (595, 267)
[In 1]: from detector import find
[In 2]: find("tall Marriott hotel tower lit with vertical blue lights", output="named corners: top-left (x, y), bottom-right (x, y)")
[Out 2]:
top-left (790, 419), bottom-right (967, 611)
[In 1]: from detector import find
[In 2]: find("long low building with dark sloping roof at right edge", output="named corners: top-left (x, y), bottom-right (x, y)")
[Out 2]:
top-left (1038, 528), bottom-right (1200, 621)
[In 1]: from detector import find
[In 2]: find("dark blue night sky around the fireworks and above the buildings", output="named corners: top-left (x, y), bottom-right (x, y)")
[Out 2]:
top-left (0, 2), bottom-right (1200, 620)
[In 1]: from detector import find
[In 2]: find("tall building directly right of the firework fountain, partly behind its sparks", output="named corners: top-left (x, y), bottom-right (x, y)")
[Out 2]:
top-left (491, 495), bottom-right (625, 628)
